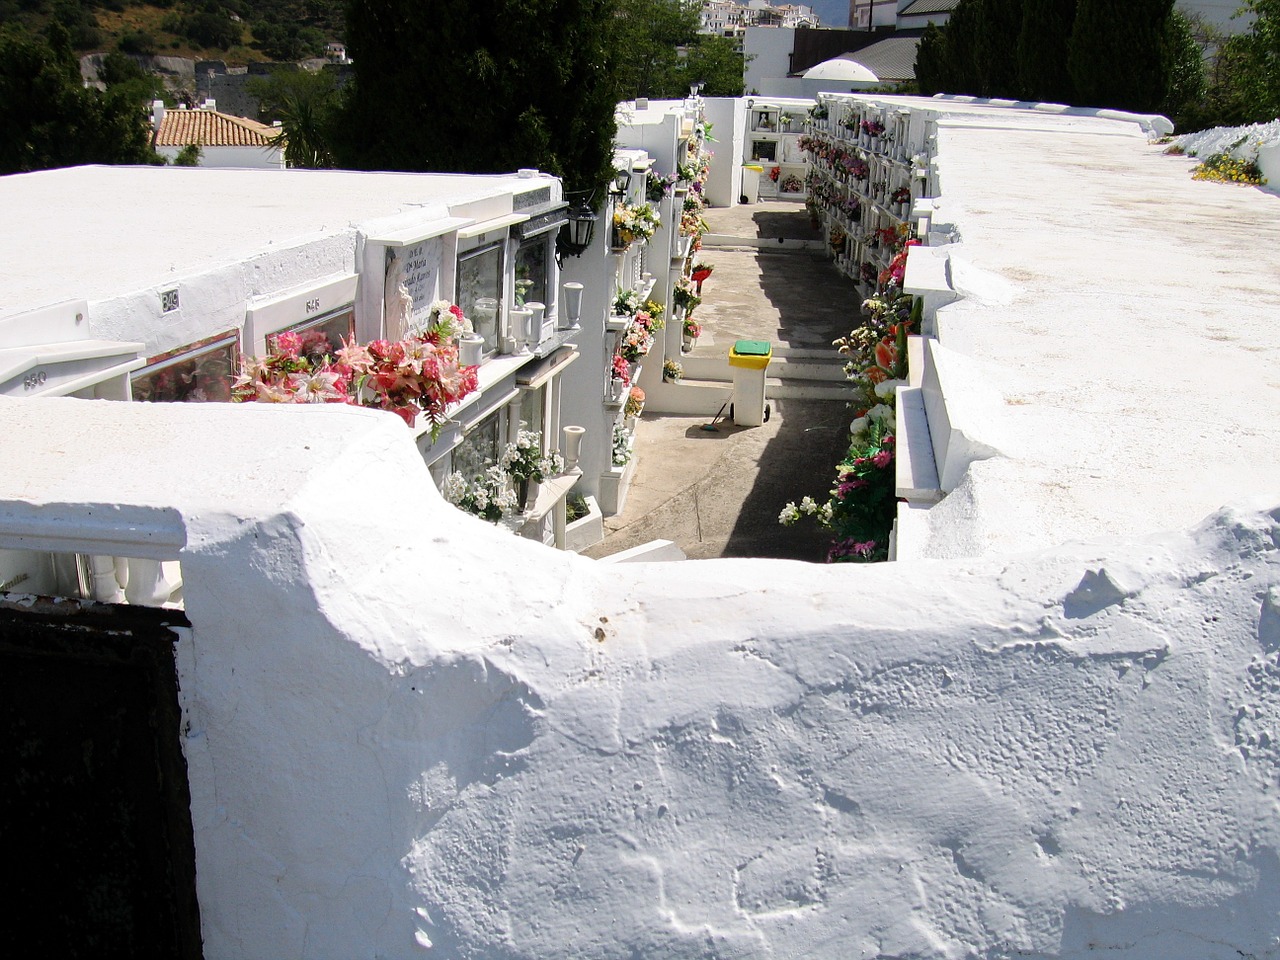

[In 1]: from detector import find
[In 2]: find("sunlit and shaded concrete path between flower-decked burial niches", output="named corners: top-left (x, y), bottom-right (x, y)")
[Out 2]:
top-left (584, 201), bottom-right (860, 562)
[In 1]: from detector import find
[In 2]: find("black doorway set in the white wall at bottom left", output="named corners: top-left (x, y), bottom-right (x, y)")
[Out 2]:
top-left (0, 598), bottom-right (201, 957)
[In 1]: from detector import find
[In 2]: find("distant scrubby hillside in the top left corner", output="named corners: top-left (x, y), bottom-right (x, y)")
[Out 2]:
top-left (0, 0), bottom-right (346, 64)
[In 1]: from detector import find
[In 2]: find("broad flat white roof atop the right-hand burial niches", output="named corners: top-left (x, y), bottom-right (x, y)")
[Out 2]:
top-left (904, 101), bottom-right (1280, 557)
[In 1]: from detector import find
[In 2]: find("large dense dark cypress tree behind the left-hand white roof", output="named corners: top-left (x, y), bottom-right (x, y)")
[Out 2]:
top-left (334, 0), bottom-right (618, 202)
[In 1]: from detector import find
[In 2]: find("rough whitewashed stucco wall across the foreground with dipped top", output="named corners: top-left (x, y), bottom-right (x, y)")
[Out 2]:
top-left (0, 401), bottom-right (1280, 960)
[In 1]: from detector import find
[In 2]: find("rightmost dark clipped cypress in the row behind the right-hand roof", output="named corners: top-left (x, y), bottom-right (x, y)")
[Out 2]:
top-left (1066, 0), bottom-right (1174, 113)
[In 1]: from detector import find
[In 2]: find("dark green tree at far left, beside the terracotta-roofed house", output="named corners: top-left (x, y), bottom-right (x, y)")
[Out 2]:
top-left (0, 23), bottom-right (155, 174)
